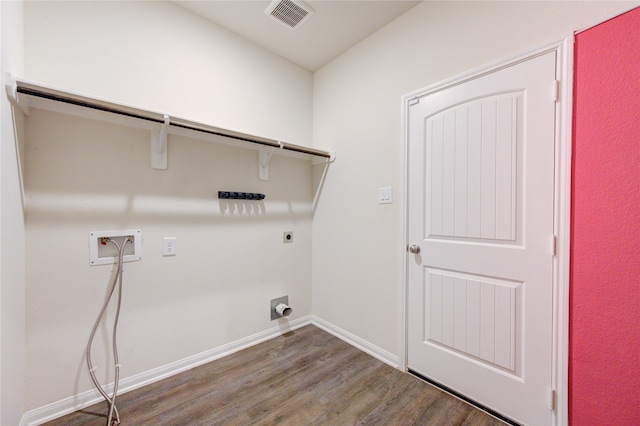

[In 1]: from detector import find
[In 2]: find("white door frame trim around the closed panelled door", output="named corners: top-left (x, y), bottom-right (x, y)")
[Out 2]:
top-left (399, 33), bottom-right (574, 425)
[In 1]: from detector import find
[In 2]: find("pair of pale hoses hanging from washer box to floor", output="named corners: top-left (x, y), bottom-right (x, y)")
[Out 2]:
top-left (86, 237), bottom-right (131, 426)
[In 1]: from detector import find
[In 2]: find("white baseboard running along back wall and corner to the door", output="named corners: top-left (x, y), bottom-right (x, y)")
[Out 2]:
top-left (20, 315), bottom-right (399, 426)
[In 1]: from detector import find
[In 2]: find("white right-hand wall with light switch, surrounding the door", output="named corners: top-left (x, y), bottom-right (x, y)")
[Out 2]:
top-left (312, 1), bottom-right (638, 363)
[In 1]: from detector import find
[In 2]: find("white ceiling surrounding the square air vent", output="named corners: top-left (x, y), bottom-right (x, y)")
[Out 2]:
top-left (175, 0), bottom-right (420, 71)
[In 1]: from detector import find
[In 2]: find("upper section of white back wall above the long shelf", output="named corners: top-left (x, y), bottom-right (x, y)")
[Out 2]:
top-left (24, 1), bottom-right (312, 144)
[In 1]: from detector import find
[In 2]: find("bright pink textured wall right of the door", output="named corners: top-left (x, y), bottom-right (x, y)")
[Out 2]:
top-left (569, 8), bottom-right (640, 426)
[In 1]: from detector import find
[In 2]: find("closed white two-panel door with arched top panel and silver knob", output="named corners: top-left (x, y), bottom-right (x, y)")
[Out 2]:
top-left (407, 52), bottom-right (556, 425)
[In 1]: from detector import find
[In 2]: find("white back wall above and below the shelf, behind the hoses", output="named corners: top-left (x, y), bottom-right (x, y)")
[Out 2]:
top-left (25, 2), bottom-right (313, 410)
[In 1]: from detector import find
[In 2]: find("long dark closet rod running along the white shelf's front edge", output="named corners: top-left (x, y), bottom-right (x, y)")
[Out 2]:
top-left (16, 83), bottom-right (332, 160)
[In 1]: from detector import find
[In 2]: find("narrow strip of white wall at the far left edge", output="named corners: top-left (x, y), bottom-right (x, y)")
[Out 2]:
top-left (0, 1), bottom-right (25, 425)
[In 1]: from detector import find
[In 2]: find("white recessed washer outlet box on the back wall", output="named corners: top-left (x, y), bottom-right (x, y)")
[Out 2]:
top-left (89, 229), bottom-right (142, 265)
